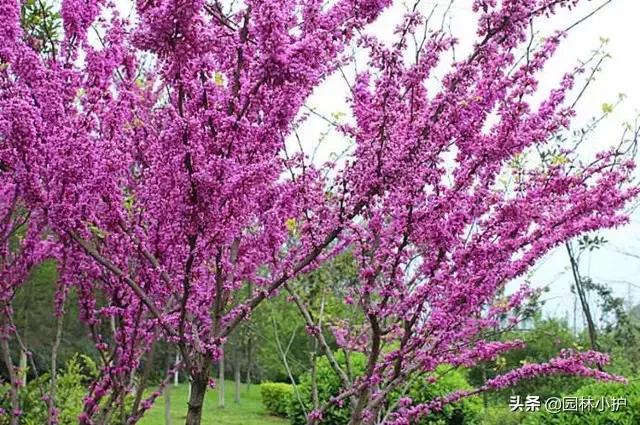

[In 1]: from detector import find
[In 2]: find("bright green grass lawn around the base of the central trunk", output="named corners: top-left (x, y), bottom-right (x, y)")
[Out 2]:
top-left (139, 381), bottom-right (289, 425)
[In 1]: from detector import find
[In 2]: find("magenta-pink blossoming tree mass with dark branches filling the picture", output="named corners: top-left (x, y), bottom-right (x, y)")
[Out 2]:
top-left (0, 0), bottom-right (637, 424)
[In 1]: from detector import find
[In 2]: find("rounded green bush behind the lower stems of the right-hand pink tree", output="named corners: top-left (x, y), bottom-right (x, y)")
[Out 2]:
top-left (289, 352), bottom-right (482, 425)
